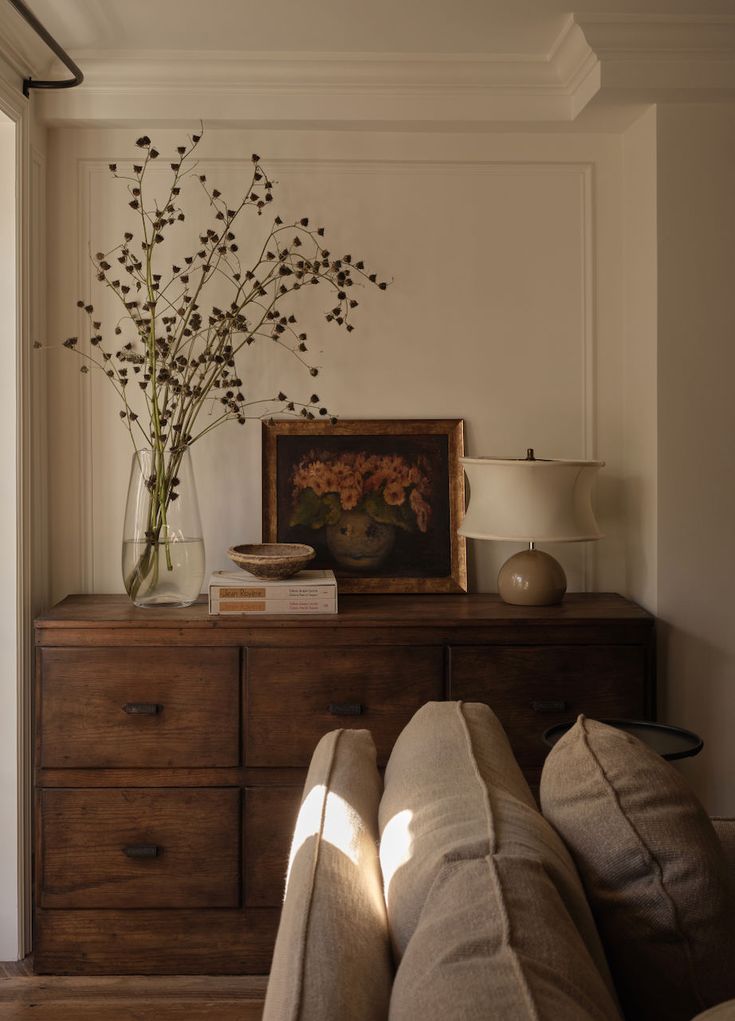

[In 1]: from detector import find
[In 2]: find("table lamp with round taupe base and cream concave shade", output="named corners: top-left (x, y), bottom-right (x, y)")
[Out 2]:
top-left (458, 447), bottom-right (604, 606)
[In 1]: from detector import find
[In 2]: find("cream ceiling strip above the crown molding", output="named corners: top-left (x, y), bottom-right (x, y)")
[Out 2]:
top-left (22, 0), bottom-right (735, 58)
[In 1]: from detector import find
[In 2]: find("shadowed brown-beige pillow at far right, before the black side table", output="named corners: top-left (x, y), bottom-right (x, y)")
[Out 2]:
top-left (541, 717), bottom-right (735, 1021)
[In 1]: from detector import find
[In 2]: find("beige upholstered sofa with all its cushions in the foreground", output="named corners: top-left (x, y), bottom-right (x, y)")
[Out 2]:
top-left (263, 702), bottom-right (735, 1021)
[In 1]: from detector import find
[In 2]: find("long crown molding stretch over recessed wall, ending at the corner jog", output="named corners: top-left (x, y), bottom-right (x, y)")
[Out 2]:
top-left (34, 17), bottom-right (592, 126)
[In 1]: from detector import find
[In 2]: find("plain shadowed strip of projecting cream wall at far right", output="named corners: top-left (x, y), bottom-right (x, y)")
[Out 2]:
top-left (657, 104), bottom-right (735, 815)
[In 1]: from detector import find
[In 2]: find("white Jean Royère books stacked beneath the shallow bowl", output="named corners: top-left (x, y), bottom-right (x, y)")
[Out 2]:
top-left (209, 571), bottom-right (337, 616)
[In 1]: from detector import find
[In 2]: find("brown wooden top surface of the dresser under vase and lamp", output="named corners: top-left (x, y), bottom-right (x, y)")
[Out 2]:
top-left (36, 592), bottom-right (652, 630)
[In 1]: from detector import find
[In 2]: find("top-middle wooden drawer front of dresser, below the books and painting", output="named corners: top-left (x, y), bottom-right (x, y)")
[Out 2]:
top-left (245, 646), bottom-right (444, 766)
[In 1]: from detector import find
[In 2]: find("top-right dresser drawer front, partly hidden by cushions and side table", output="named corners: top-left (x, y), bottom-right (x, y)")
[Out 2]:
top-left (450, 645), bottom-right (647, 766)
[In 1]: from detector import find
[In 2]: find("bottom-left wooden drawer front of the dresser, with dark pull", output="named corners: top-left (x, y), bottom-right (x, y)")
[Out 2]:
top-left (39, 788), bottom-right (241, 909)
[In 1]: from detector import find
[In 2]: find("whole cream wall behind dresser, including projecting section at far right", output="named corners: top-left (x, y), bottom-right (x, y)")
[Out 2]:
top-left (43, 111), bottom-right (735, 812)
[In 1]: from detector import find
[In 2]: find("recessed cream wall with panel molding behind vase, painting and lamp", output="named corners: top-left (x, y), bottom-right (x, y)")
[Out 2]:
top-left (48, 125), bottom-right (630, 599)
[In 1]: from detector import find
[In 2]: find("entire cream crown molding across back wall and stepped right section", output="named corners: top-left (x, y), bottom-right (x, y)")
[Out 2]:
top-left (34, 14), bottom-right (735, 131)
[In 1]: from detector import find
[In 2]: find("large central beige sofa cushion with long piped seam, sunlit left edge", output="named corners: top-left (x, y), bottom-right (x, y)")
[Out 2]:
top-left (380, 702), bottom-right (620, 1021)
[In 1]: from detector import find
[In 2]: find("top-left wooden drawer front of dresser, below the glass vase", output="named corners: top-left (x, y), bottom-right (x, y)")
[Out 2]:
top-left (40, 647), bottom-right (240, 769)
